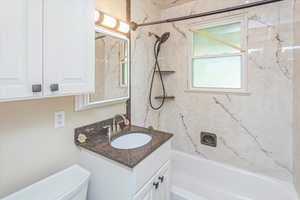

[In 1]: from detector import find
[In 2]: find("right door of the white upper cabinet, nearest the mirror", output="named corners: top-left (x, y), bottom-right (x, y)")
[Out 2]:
top-left (44, 0), bottom-right (95, 96)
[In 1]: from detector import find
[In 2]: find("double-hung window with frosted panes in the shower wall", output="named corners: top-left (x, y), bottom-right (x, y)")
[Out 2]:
top-left (189, 16), bottom-right (247, 92)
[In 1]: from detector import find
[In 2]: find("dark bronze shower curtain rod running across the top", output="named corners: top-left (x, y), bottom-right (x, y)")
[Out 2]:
top-left (131, 0), bottom-right (284, 31)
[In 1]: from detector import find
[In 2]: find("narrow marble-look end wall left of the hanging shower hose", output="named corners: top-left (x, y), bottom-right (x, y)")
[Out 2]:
top-left (131, 0), bottom-right (164, 127)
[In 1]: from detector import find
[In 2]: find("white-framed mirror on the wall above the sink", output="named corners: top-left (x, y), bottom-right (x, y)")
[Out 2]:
top-left (76, 27), bottom-right (130, 111)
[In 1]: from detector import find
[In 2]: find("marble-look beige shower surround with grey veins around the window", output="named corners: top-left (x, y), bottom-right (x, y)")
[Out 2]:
top-left (132, 0), bottom-right (293, 181)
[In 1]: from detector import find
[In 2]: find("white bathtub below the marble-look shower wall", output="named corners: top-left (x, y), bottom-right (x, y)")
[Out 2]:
top-left (171, 151), bottom-right (298, 200)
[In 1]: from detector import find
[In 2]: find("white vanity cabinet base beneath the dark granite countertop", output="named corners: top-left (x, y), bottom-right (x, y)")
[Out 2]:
top-left (80, 141), bottom-right (171, 200)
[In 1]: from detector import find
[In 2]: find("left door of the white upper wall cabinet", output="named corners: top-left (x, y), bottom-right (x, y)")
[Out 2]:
top-left (0, 0), bottom-right (43, 101)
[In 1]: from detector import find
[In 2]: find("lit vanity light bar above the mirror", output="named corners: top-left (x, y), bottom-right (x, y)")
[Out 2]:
top-left (95, 10), bottom-right (130, 34)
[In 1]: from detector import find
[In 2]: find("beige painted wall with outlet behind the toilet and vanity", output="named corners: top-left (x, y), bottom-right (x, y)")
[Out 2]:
top-left (0, 0), bottom-right (126, 198)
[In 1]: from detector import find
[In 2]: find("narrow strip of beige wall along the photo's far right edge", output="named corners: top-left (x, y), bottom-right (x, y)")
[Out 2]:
top-left (294, 0), bottom-right (300, 195)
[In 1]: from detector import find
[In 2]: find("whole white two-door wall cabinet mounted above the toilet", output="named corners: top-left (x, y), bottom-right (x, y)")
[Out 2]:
top-left (0, 0), bottom-right (95, 102)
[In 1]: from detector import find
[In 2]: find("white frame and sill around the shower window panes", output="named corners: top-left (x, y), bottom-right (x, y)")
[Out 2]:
top-left (186, 15), bottom-right (248, 93)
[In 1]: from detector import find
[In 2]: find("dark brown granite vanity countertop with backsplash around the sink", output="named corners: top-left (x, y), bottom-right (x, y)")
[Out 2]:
top-left (74, 124), bottom-right (173, 168)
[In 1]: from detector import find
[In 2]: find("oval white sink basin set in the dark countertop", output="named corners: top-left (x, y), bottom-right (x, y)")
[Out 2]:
top-left (111, 133), bottom-right (152, 149)
